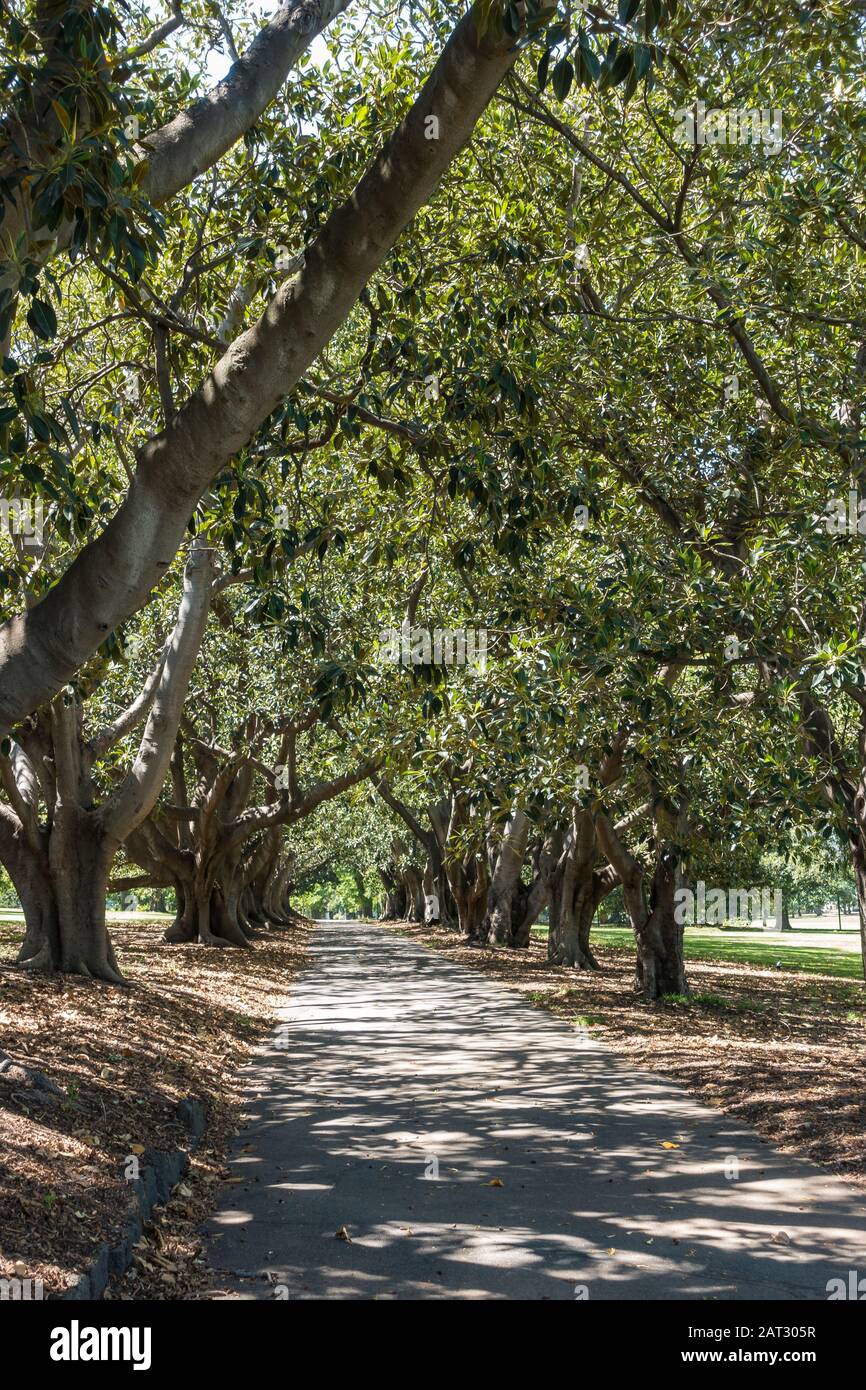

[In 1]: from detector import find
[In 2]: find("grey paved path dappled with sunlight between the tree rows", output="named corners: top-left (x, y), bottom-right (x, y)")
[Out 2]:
top-left (207, 923), bottom-right (866, 1300)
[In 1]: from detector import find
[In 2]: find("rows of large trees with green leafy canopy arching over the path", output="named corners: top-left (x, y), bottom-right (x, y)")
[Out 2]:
top-left (0, 0), bottom-right (866, 998)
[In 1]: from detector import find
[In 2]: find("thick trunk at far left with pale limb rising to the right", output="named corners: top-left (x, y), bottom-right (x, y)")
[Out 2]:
top-left (0, 543), bottom-right (213, 984)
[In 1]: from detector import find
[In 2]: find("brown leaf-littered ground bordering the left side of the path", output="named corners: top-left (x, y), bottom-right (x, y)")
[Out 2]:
top-left (0, 917), bottom-right (307, 1298)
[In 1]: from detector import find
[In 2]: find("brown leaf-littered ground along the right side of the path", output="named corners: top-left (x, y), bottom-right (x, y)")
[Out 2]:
top-left (392, 924), bottom-right (866, 1186)
